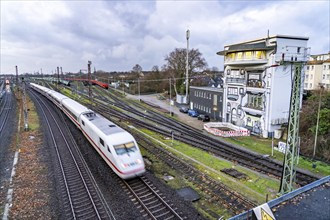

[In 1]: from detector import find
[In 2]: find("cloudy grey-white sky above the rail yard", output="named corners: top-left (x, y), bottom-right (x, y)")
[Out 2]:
top-left (0, 0), bottom-right (330, 74)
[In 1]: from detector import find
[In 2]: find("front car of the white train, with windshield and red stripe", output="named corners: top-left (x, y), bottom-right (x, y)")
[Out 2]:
top-left (80, 112), bottom-right (145, 179)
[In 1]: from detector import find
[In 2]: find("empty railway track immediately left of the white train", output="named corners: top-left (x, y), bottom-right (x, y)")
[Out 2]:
top-left (30, 91), bottom-right (115, 219)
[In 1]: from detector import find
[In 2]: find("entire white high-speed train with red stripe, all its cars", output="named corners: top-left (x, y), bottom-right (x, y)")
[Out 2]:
top-left (30, 83), bottom-right (145, 179)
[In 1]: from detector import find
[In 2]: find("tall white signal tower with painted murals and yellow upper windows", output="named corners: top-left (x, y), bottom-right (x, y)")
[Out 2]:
top-left (217, 35), bottom-right (309, 138)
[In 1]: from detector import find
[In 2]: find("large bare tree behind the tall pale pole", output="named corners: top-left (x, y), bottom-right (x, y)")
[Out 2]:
top-left (165, 48), bottom-right (207, 94)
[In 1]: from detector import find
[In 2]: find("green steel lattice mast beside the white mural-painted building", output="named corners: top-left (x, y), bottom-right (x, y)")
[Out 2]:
top-left (280, 62), bottom-right (303, 194)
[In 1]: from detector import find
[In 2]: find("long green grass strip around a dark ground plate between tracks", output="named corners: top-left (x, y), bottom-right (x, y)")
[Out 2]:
top-left (138, 129), bottom-right (279, 204)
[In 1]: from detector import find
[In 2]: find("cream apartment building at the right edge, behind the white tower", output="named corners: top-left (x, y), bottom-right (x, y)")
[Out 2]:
top-left (304, 52), bottom-right (330, 90)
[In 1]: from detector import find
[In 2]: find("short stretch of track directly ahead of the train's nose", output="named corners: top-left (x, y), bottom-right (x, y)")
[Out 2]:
top-left (124, 176), bottom-right (186, 220)
